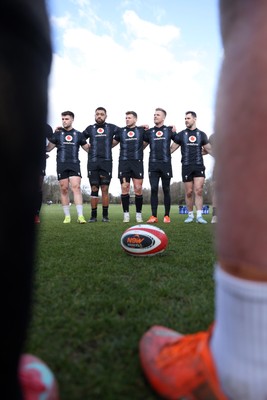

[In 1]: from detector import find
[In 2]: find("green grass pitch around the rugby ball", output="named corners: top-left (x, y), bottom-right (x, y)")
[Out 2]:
top-left (26, 205), bottom-right (219, 400)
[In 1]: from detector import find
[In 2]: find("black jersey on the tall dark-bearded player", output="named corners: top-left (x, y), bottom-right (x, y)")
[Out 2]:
top-left (83, 122), bottom-right (120, 162)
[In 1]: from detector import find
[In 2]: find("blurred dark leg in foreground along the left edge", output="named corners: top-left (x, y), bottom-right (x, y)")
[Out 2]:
top-left (0, 0), bottom-right (56, 400)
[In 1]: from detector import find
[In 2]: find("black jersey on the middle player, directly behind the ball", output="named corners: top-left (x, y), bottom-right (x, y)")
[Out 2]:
top-left (114, 126), bottom-right (145, 161)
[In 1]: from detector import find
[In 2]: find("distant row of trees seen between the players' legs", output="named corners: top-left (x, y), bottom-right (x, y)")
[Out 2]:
top-left (43, 175), bottom-right (212, 205)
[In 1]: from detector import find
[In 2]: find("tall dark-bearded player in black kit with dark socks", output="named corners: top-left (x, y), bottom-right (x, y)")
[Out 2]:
top-left (83, 107), bottom-right (120, 222)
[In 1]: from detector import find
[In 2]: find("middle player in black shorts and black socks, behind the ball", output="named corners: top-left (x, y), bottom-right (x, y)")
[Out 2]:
top-left (113, 111), bottom-right (148, 223)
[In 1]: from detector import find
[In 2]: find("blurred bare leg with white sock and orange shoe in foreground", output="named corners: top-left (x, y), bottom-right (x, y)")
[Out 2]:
top-left (140, 0), bottom-right (267, 400)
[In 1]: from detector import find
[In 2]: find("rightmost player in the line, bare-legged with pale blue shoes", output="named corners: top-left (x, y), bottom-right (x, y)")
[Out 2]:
top-left (171, 111), bottom-right (214, 224)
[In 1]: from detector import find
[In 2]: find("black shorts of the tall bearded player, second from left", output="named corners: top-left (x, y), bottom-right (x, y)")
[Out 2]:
top-left (88, 160), bottom-right (112, 187)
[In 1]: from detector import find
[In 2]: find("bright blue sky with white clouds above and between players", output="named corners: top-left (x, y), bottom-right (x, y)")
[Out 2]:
top-left (46, 0), bottom-right (223, 195)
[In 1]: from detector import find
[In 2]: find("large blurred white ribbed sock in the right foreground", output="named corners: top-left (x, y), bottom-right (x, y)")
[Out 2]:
top-left (211, 266), bottom-right (267, 400)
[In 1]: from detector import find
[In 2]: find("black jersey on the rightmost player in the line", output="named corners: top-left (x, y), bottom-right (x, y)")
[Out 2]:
top-left (174, 128), bottom-right (209, 165)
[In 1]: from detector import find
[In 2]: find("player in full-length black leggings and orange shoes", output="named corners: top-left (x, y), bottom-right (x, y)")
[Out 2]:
top-left (144, 108), bottom-right (178, 224)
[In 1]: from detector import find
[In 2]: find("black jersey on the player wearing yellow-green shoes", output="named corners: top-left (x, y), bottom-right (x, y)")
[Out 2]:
top-left (49, 128), bottom-right (87, 164)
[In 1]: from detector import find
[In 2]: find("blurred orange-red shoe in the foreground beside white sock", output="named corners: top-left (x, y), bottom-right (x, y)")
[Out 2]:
top-left (139, 325), bottom-right (227, 400)
